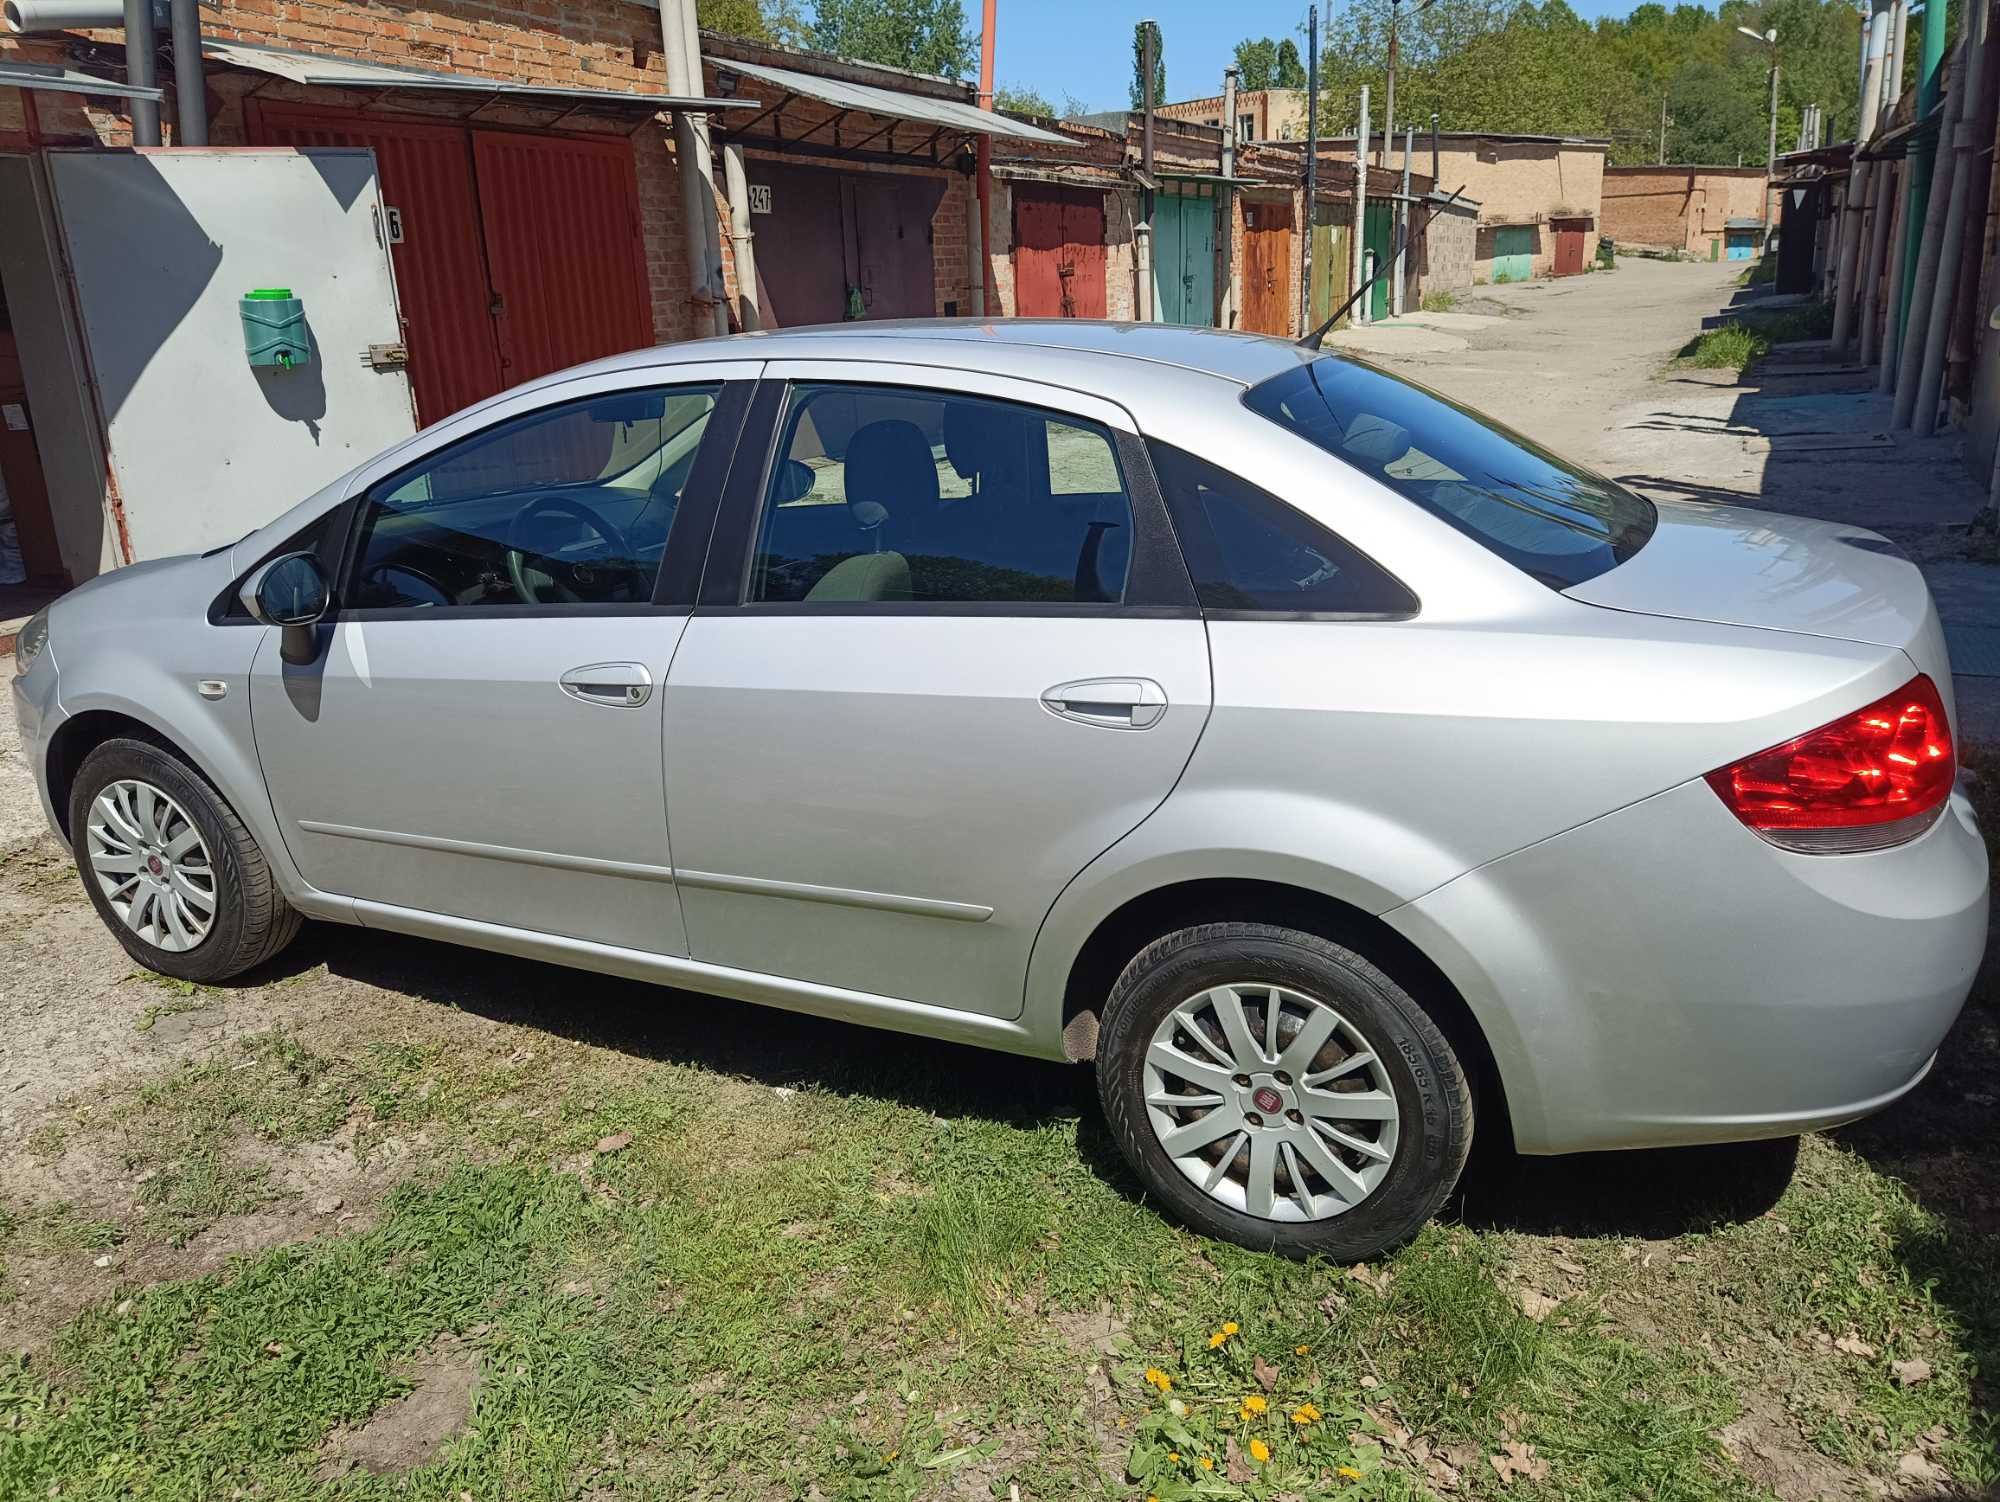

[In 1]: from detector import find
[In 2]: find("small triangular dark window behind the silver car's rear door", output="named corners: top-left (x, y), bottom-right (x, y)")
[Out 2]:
top-left (1148, 442), bottom-right (1416, 620)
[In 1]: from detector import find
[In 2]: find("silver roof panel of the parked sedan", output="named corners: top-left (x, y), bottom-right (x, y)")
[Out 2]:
top-left (544, 318), bottom-right (1316, 386)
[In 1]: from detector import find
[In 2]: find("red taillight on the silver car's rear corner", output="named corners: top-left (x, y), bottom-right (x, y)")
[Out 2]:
top-left (1708, 674), bottom-right (1958, 854)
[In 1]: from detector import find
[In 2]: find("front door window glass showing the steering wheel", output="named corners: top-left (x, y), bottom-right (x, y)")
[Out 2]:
top-left (346, 386), bottom-right (720, 610)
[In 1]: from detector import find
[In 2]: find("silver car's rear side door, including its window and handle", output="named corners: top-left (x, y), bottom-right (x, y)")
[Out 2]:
top-left (664, 362), bottom-right (1210, 1018)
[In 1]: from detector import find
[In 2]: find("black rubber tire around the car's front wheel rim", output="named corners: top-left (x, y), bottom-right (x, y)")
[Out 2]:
top-left (70, 738), bottom-right (302, 982)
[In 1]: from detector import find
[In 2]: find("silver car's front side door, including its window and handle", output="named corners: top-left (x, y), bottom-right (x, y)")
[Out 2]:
top-left (250, 364), bottom-right (758, 954)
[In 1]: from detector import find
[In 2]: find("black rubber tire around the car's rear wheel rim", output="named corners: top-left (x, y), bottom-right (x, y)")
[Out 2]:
top-left (1098, 922), bottom-right (1472, 1262)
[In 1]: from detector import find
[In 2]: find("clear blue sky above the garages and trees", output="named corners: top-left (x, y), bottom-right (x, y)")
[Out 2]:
top-left (996, 0), bottom-right (1632, 110)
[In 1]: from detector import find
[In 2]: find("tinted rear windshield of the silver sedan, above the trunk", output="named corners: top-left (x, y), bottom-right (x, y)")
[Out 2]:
top-left (1244, 358), bottom-right (1656, 590)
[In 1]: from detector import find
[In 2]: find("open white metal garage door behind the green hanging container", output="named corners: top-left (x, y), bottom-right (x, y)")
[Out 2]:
top-left (50, 148), bottom-right (416, 560)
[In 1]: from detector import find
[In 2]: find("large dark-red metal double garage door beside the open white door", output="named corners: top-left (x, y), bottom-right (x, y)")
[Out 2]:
top-left (246, 100), bottom-right (652, 424)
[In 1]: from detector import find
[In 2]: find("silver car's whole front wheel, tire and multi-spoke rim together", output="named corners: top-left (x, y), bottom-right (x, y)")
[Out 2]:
top-left (70, 738), bottom-right (300, 982)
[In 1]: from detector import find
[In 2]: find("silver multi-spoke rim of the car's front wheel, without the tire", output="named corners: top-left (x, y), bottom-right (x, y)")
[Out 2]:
top-left (84, 778), bottom-right (216, 954)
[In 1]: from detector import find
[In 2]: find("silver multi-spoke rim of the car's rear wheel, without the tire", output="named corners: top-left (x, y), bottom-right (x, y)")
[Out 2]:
top-left (1146, 982), bottom-right (1400, 1222)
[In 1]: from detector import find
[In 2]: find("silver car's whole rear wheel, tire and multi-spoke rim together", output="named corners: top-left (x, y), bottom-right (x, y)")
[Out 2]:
top-left (1098, 922), bottom-right (1472, 1260)
